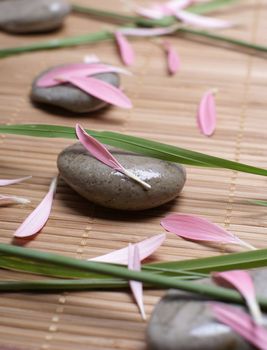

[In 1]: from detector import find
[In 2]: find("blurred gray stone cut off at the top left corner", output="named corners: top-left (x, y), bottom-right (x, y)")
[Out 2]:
top-left (0, 0), bottom-right (71, 33)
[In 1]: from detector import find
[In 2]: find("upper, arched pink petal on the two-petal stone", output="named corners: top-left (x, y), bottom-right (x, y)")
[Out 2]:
top-left (36, 63), bottom-right (131, 87)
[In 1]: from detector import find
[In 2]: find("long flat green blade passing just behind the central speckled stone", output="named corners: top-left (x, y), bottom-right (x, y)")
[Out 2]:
top-left (0, 124), bottom-right (267, 176)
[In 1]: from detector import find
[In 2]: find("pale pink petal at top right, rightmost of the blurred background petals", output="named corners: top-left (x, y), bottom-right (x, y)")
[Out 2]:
top-left (175, 11), bottom-right (232, 29)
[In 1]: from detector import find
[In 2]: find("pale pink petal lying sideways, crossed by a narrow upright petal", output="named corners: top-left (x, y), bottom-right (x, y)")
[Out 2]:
top-left (88, 233), bottom-right (166, 265)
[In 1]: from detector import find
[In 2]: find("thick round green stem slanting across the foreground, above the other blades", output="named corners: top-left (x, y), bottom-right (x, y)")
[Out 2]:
top-left (0, 244), bottom-right (267, 309)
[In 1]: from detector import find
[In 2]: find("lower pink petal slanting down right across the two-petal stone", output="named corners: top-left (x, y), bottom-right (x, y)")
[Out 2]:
top-left (68, 77), bottom-right (132, 109)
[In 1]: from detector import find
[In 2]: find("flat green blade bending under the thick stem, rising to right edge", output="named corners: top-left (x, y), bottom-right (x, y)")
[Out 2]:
top-left (0, 249), bottom-right (267, 279)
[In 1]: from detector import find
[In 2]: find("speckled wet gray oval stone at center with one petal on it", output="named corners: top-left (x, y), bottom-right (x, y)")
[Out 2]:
top-left (57, 143), bottom-right (186, 210)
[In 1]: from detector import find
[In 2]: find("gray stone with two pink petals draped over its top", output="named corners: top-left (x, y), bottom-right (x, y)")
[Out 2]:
top-left (31, 65), bottom-right (120, 113)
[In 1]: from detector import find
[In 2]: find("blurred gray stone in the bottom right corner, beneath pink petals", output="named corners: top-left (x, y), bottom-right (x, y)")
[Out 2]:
top-left (147, 269), bottom-right (267, 350)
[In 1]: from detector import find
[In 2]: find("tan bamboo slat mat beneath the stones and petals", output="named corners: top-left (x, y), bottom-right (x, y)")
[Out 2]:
top-left (0, 0), bottom-right (267, 350)
